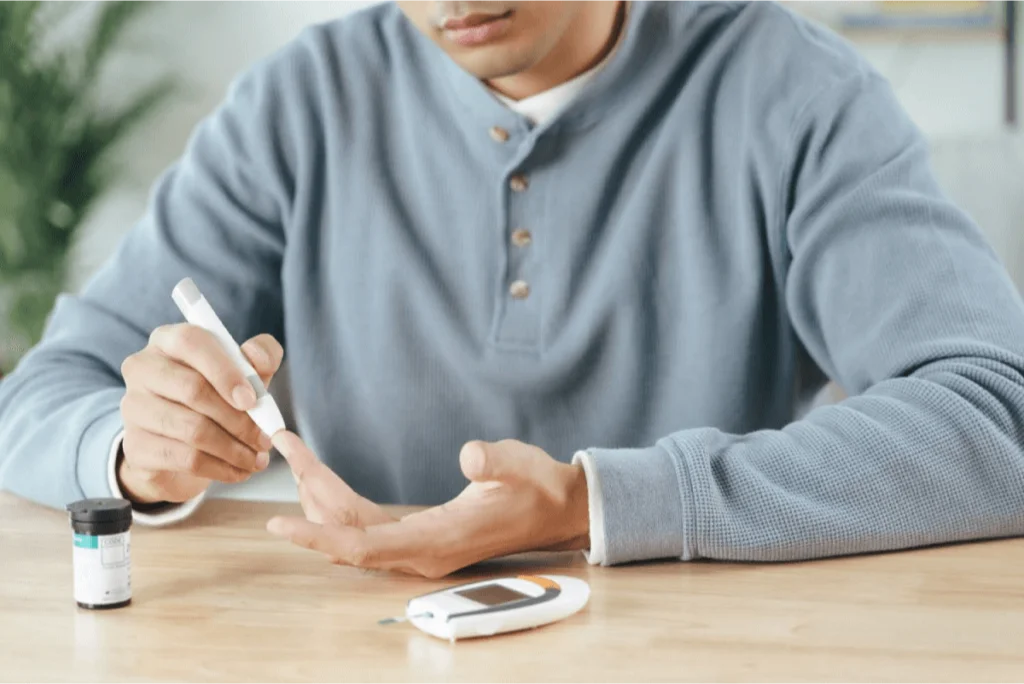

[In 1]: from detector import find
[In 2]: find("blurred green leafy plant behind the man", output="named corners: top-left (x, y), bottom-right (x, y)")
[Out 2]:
top-left (0, 0), bottom-right (176, 373)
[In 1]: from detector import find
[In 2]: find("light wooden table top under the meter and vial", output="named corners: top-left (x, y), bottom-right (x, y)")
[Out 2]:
top-left (6, 495), bottom-right (1024, 684)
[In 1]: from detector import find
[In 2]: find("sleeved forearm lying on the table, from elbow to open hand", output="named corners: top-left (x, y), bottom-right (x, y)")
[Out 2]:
top-left (592, 355), bottom-right (1024, 564)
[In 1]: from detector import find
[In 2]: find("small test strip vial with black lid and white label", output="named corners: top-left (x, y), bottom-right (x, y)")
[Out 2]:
top-left (68, 499), bottom-right (132, 610)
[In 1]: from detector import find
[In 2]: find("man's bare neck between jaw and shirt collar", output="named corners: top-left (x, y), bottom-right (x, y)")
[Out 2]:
top-left (487, 0), bottom-right (629, 99)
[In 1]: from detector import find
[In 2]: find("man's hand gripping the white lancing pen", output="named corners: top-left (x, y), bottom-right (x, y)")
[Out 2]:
top-left (117, 324), bottom-right (284, 504)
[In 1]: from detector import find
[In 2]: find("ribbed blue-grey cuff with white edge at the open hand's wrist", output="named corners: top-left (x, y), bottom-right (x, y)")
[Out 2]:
top-left (573, 445), bottom-right (694, 565)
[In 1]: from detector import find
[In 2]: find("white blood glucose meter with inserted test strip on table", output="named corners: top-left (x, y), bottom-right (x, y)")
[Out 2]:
top-left (382, 574), bottom-right (590, 641)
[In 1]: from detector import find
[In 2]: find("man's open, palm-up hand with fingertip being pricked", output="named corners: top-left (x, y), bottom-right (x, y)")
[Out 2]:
top-left (267, 433), bottom-right (590, 579)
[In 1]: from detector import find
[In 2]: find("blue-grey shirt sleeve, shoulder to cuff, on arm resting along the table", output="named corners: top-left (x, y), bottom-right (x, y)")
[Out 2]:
top-left (589, 69), bottom-right (1024, 564)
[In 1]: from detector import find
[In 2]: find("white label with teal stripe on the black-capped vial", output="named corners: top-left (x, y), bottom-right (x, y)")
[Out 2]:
top-left (74, 530), bottom-right (131, 605)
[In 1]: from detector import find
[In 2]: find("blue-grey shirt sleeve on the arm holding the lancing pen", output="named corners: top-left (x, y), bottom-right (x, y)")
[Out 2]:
top-left (0, 38), bottom-right (305, 508)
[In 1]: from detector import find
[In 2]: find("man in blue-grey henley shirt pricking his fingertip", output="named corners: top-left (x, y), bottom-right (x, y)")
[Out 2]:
top-left (0, 0), bottom-right (1024, 576)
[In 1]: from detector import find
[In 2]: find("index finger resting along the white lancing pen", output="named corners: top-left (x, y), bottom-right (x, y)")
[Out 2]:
top-left (150, 324), bottom-right (256, 411)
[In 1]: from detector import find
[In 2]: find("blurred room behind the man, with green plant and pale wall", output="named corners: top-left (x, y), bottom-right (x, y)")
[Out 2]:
top-left (0, 0), bottom-right (1024, 371)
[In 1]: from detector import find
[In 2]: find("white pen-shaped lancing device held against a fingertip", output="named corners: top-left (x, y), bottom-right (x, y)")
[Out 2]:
top-left (171, 277), bottom-right (285, 437)
